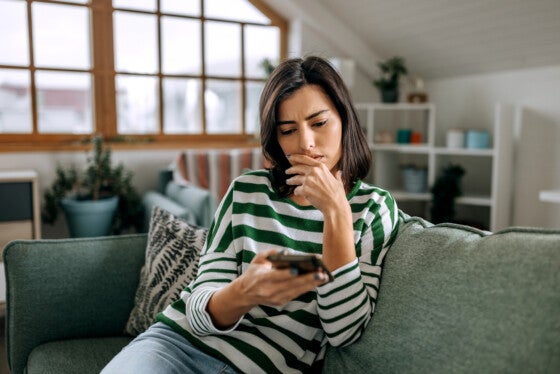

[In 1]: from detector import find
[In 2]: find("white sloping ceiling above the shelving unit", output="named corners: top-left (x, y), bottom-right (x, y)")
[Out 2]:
top-left (264, 0), bottom-right (560, 79)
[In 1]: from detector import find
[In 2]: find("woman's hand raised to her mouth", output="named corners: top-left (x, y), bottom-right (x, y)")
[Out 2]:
top-left (286, 154), bottom-right (349, 214)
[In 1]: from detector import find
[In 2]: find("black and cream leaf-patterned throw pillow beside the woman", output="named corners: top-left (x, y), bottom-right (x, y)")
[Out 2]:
top-left (125, 206), bottom-right (207, 336)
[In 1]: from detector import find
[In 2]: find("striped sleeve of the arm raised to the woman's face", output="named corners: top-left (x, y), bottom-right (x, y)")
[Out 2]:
top-left (317, 191), bottom-right (398, 347)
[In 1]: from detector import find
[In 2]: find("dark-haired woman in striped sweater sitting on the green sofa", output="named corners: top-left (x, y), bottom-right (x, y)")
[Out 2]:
top-left (100, 57), bottom-right (398, 373)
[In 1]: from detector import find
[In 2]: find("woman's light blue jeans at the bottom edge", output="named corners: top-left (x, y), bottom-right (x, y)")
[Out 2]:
top-left (101, 322), bottom-right (237, 374)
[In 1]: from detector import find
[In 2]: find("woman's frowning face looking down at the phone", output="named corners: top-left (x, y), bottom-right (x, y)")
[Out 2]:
top-left (276, 85), bottom-right (342, 173)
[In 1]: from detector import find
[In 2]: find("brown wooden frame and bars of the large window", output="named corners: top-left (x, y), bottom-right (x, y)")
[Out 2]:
top-left (0, 0), bottom-right (287, 152)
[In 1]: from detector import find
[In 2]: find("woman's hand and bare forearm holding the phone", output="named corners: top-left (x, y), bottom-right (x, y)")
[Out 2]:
top-left (207, 250), bottom-right (328, 329)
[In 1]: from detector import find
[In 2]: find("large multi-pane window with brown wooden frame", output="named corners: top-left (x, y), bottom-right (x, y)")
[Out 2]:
top-left (0, 0), bottom-right (286, 146)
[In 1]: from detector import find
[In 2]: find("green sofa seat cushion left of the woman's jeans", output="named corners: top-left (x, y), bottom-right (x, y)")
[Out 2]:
top-left (26, 337), bottom-right (132, 374)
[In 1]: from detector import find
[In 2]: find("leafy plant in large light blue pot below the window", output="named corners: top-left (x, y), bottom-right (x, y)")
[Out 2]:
top-left (41, 136), bottom-right (143, 237)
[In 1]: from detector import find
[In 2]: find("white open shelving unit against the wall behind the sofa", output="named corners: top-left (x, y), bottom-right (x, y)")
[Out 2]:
top-left (356, 103), bottom-right (516, 231)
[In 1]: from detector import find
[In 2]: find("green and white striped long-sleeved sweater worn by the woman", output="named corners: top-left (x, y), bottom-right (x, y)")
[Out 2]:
top-left (157, 170), bottom-right (398, 373)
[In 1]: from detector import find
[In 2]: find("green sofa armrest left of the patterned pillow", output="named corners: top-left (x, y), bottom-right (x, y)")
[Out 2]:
top-left (4, 234), bottom-right (147, 373)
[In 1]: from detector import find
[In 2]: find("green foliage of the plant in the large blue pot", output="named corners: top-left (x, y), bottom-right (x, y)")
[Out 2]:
top-left (41, 135), bottom-right (143, 234)
